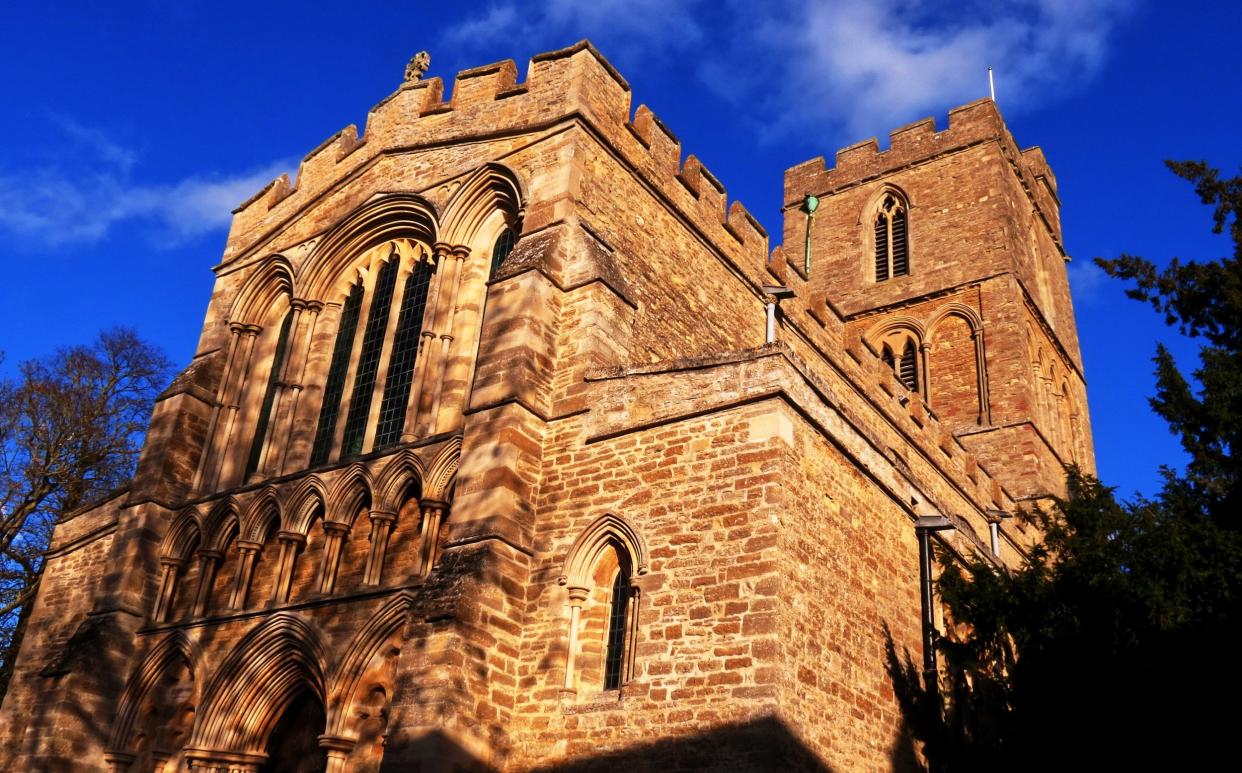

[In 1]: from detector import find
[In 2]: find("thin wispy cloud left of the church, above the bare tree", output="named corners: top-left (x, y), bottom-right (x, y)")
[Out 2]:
top-left (0, 118), bottom-right (289, 246)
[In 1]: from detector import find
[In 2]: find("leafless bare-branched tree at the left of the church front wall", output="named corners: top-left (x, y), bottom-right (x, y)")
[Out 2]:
top-left (0, 328), bottom-right (170, 698)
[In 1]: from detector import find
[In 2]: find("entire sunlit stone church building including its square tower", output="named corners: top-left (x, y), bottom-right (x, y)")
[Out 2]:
top-left (0, 42), bottom-right (1093, 773)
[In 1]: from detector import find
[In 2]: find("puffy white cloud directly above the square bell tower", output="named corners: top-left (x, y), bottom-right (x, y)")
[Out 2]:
top-left (760, 0), bottom-right (1125, 135)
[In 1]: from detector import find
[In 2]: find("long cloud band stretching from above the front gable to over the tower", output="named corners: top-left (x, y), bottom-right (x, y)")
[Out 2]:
top-left (448, 0), bottom-right (1133, 139)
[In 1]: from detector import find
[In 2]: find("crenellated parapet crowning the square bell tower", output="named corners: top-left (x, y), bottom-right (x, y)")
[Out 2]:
top-left (784, 98), bottom-right (1064, 248)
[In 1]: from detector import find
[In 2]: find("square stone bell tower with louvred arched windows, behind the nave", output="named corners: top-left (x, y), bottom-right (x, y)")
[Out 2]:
top-left (785, 99), bottom-right (1094, 497)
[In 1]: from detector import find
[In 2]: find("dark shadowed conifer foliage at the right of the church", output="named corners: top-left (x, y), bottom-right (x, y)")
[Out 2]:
top-left (889, 162), bottom-right (1242, 771)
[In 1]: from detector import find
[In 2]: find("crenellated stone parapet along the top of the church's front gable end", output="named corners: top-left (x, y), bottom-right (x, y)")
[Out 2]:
top-left (217, 40), bottom-right (769, 282)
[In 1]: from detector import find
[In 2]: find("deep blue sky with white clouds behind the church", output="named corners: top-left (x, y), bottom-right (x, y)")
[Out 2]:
top-left (0, 0), bottom-right (1242, 496)
